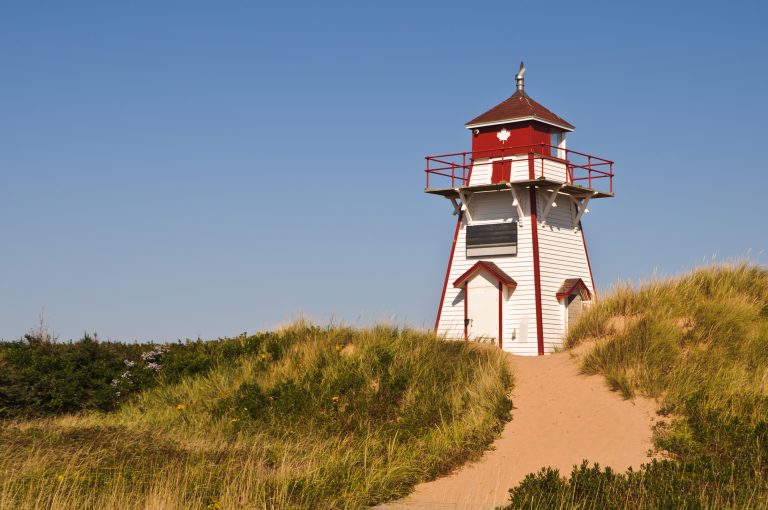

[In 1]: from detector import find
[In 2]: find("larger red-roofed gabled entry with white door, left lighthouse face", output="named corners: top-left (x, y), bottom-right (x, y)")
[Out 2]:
top-left (453, 260), bottom-right (517, 348)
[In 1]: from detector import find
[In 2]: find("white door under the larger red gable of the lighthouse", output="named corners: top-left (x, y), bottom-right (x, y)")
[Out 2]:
top-left (467, 271), bottom-right (499, 341)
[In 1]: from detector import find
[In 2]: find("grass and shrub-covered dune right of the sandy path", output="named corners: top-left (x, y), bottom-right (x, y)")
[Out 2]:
top-left (500, 264), bottom-right (768, 509)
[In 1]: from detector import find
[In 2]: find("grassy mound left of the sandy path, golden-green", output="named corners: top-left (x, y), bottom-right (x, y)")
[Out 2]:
top-left (0, 324), bottom-right (511, 509)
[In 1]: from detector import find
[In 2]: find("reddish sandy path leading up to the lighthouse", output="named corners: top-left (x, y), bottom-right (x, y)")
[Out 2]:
top-left (376, 352), bottom-right (656, 510)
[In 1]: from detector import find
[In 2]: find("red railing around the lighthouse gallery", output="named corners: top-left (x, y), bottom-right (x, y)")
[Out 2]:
top-left (425, 144), bottom-right (613, 193)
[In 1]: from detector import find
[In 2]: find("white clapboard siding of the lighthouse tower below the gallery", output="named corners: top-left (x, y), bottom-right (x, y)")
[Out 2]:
top-left (437, 185), bottom-right (594, 355)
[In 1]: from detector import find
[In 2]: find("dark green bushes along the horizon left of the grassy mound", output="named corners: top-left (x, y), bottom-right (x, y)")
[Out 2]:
top-left (0, 333), bottom-right (294, 419)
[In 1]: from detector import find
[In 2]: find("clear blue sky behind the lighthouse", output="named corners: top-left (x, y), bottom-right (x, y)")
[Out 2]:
top-left (0, 1), bottom-right (768, 341)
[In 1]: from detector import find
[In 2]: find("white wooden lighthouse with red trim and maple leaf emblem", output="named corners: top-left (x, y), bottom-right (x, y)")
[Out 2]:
top-left (425, 63), bottom-right (613, 355)
